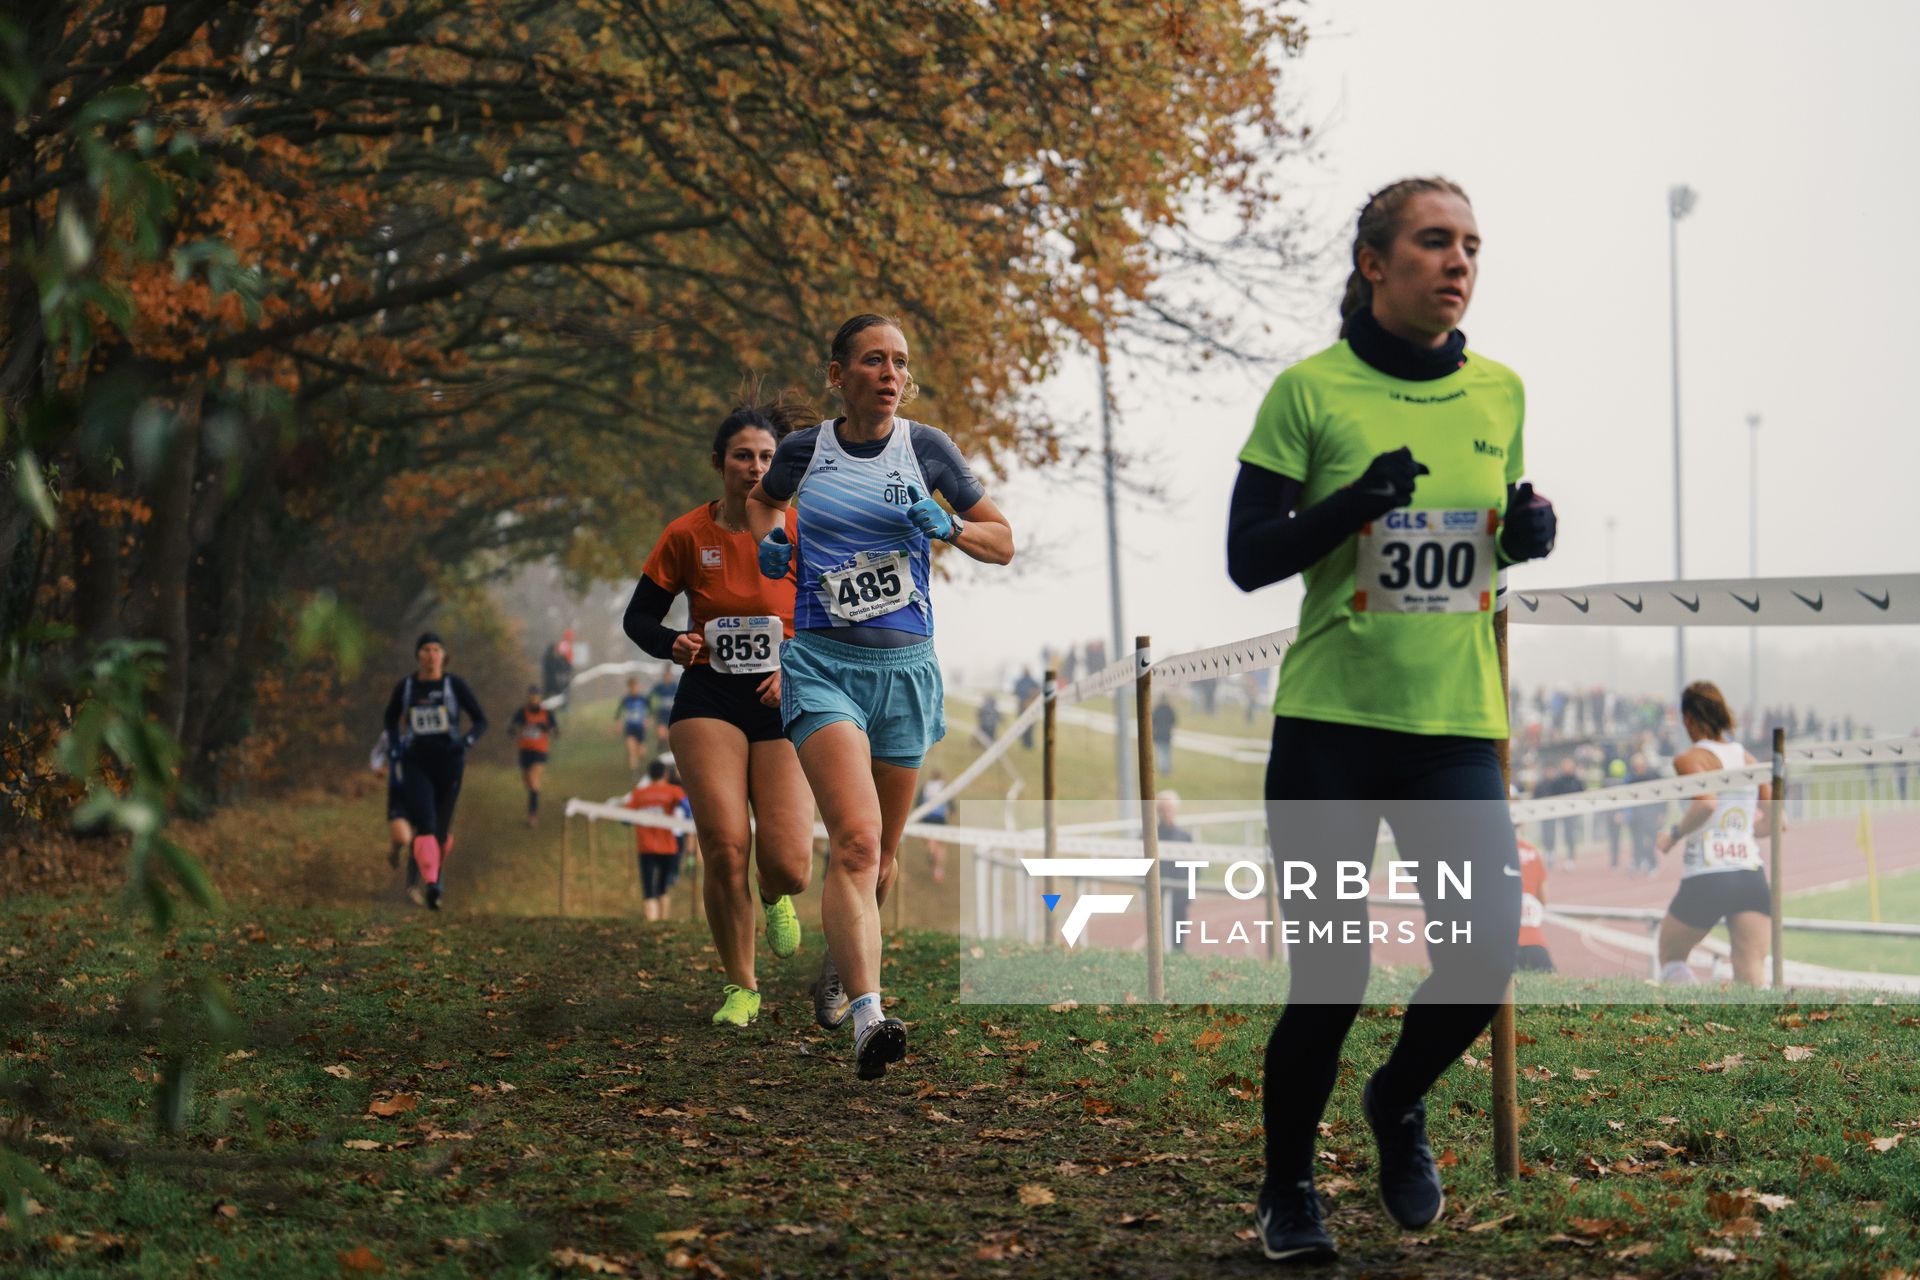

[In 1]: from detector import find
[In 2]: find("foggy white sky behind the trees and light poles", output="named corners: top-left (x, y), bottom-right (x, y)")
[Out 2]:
top-left (935, 0), bottom-right (1920, 731)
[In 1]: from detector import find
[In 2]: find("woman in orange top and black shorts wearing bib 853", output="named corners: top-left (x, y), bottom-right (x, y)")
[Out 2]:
top-left (626, 405), bottom-right (814, 1027)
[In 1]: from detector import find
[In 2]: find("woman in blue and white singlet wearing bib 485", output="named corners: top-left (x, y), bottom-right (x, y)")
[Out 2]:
top-left (747, 315), bottom-right (1014, 1079)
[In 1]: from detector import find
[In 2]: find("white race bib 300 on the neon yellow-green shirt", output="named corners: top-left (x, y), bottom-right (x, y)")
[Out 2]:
top-left (1354, 509), bottom-right (1500, 614)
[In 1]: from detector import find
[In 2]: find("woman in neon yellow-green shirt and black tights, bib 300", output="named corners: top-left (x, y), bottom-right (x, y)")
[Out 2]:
top-left (1227, 178), bottom-right (1555, 1261)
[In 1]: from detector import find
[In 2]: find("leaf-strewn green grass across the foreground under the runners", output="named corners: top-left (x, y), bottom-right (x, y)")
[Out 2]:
top-left (0, 902), bottom-right (1920, 1280)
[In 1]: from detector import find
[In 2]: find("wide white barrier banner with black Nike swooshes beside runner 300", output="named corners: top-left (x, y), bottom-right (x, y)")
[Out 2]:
top-left (1507, 574), bottom-right (1920, 628)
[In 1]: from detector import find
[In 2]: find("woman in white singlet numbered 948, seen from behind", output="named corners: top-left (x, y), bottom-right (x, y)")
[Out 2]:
top-left (1653, 679), bottom-right (1774, 986)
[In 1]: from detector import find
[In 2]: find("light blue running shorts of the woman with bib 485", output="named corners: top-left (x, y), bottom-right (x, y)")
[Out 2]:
top-left (780, 631), bottom-right (947, 770)
